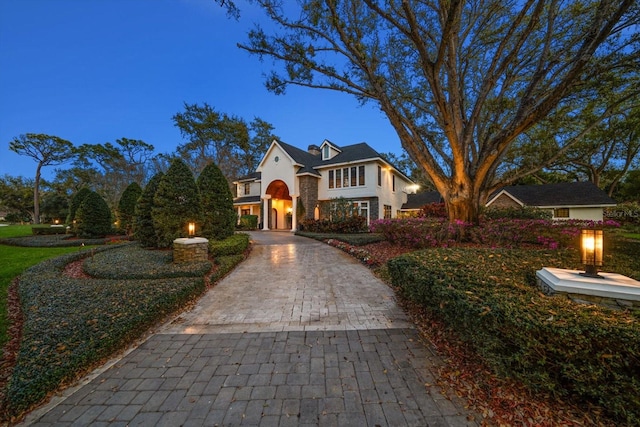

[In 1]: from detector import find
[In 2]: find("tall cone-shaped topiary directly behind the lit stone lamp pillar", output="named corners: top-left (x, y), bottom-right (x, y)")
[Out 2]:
top-left (151, 159), bottom-right (202, 248)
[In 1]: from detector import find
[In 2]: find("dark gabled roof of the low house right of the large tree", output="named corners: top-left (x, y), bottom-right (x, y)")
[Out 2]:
top-left (487, 182), bottom-right (616, 208)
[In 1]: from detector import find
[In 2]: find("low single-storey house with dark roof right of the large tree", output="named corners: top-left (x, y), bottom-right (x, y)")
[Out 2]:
top-left (487, 182), bottom-right (616, 221)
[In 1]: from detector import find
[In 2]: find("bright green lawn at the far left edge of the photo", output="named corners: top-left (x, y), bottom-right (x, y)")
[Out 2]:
top-left (0, 225), bottom-right (87, 347)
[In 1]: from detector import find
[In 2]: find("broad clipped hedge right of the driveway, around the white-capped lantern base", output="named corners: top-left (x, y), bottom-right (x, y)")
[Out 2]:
top-left (388, 245), bottom-right (640, 425)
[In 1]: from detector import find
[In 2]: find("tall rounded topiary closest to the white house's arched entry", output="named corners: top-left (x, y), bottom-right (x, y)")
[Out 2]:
top-left (197, 163), bottom-right (237, 240)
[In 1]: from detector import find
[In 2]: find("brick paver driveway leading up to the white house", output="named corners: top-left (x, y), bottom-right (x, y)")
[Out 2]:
top-left (25, 232), bottom-right (479, 426)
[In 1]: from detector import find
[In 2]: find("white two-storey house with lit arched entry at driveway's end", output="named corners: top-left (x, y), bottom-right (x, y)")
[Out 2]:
top-left (234, 140), bottom-right (415, 230)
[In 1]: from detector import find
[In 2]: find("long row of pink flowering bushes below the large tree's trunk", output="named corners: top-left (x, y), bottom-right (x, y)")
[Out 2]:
top-left (369, 218), bottom-right (620, 249)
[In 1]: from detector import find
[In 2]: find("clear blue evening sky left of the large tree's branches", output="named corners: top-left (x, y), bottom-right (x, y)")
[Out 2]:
top-left (0, 0), bottom-right (401, 178)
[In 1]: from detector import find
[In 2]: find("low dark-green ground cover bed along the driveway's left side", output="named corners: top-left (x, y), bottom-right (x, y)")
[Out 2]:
top-left (0, 232), bottom-right (248, 421)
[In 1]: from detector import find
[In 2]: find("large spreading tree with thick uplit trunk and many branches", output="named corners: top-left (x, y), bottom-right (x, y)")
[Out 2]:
top-left (239, 0), bottom-right (640, 222)
